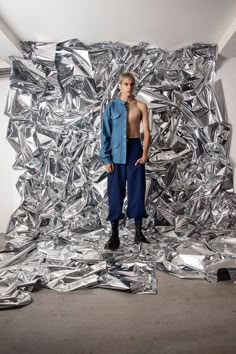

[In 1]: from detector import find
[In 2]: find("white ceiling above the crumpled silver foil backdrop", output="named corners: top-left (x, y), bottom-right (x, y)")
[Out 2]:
top-left (0, 0), bottom-right (236, 65)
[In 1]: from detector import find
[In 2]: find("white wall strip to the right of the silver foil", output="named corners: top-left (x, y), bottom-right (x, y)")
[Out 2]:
top-left (215, 58), bottom-right (236, 192)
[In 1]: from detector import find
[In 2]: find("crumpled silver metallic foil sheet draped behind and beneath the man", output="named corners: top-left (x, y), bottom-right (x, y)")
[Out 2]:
top-left (0, 39), bottom-right (236, 308)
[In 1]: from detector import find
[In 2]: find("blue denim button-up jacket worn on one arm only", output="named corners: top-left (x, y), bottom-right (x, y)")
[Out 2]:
top-left (100, 98), bottom-right (127, 165)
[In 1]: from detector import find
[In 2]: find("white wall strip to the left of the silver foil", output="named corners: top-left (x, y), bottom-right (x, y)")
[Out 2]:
top-left (0, 78), bottom-right (22, 233)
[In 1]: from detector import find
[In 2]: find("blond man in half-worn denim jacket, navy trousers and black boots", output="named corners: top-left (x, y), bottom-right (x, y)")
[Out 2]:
top-left (100, 72), bottom-right (150, 251)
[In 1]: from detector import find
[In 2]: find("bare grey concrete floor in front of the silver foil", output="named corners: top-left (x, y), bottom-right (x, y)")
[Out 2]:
top-left (0, 234), bottom-right (236, 354)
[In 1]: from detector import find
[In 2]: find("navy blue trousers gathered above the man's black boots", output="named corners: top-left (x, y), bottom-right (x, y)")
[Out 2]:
top-left (106, 138), bottom-right (148, 223)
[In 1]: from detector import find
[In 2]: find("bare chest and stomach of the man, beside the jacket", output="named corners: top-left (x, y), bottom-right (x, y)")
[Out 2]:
top-left (127, 99), bottom-right (142, 138)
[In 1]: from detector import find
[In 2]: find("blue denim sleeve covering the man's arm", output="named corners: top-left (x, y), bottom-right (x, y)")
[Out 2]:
top-left (100, 103), bottom-right (112, 165)
